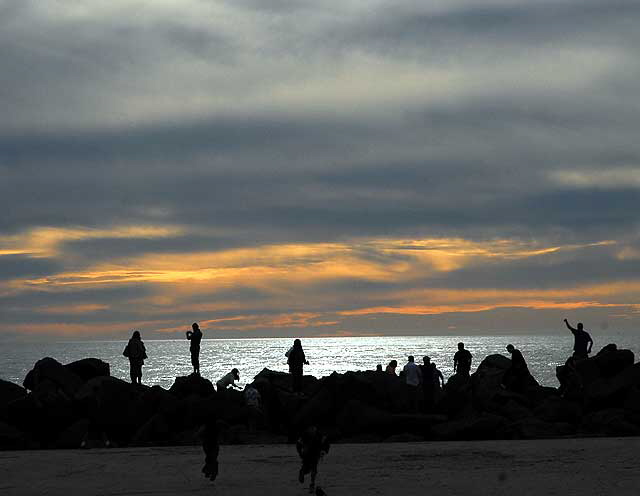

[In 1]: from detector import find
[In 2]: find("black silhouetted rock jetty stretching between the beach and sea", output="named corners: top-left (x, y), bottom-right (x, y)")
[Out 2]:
top-left (0, 345), bottom-right (640, 449)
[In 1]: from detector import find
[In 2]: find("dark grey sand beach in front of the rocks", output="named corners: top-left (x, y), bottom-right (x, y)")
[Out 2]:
top-left (0, 438), bottom-right (640, 496)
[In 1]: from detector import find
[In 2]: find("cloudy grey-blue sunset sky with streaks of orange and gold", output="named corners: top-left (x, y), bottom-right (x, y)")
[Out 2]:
top-left (0, 0), bottom-right (640, 340)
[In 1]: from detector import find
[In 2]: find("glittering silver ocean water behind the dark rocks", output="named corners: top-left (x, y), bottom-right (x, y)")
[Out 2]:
top-left (0, 331), bottom-right (640, 388)
